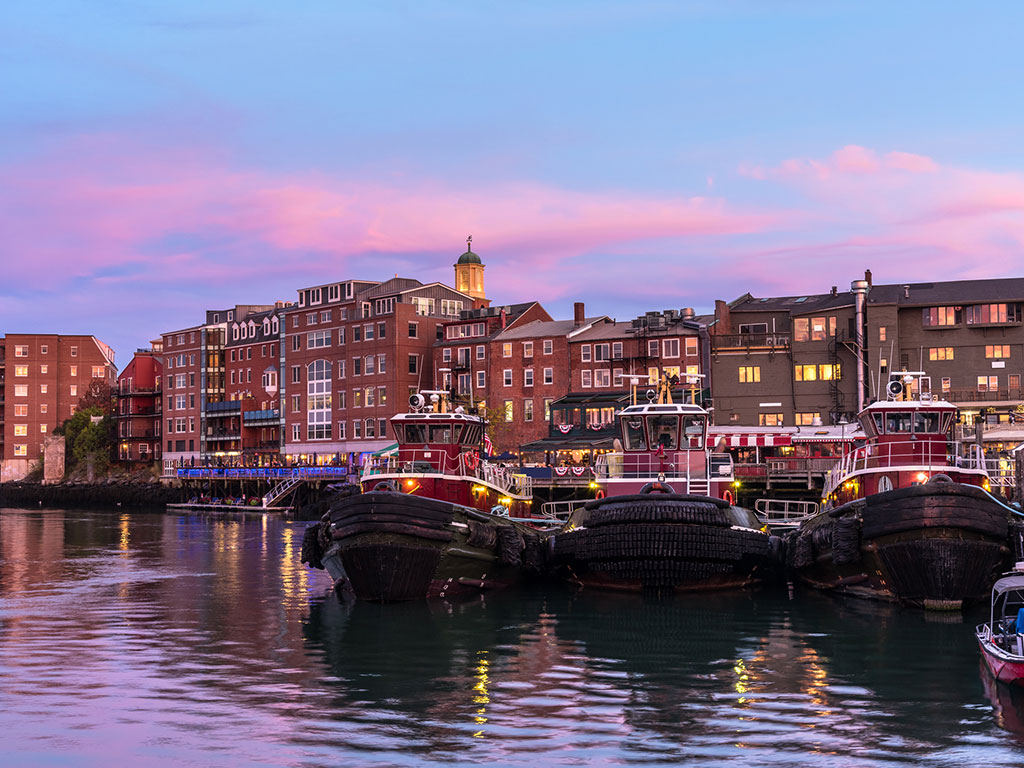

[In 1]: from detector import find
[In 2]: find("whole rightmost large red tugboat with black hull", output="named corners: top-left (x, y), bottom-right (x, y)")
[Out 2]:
top-left (787, 372), bottom-right (1010, 610)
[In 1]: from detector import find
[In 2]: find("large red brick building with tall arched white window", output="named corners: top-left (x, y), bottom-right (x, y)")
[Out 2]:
top-left (281, 274), bottom-right (477, 463)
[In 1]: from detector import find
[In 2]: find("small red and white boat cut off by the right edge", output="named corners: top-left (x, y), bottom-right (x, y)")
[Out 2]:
top-left (975, 562), bottom-right (1024, 685)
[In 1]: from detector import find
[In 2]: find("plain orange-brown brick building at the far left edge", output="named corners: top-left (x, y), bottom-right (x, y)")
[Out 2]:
top-left (0, 334), bottom-right (118, 481)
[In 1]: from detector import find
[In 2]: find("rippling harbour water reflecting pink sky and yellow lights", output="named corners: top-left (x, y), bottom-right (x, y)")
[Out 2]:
top-left (0, 510), bottom-right (1024, 768)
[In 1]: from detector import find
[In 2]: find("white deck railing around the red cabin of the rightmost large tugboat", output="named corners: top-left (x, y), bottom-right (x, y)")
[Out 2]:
top-left (822, 440), bottom-right (986, 497)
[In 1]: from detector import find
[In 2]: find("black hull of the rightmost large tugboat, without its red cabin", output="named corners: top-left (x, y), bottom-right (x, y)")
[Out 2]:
top-left (787, 482), bottom-right (1009, 610)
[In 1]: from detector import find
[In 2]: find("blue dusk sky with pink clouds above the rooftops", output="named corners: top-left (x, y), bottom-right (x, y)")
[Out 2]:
top-left (0, 0), bottom-right (1024, 368)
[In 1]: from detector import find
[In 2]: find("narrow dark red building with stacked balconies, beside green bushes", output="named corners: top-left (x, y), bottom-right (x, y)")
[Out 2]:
top-left (116, 340), bottom-right (164, 467)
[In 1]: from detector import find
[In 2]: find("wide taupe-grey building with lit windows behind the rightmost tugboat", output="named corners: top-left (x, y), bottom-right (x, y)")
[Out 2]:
top-left (709, 270), bottom-right (1024, 426)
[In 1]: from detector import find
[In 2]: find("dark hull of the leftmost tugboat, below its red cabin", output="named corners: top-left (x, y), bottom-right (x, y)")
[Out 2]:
top-left (303, 490), bottom-right (542, 602)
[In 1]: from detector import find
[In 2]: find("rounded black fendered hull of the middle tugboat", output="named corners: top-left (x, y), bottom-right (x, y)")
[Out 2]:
top-left (552, 494), bottom-right (778, 591)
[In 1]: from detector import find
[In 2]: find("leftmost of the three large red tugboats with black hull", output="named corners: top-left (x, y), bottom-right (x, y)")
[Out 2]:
top-left (303, 392), bottom-right (554, 602)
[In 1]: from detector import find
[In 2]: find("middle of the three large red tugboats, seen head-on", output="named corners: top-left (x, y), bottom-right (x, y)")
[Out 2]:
top-left (552, 378), bottom-right (780, 592)
